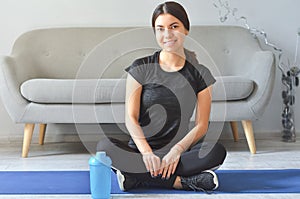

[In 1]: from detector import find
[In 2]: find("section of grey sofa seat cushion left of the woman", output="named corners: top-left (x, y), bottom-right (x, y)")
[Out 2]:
top-left (21, 79), bottom-right (126, 104)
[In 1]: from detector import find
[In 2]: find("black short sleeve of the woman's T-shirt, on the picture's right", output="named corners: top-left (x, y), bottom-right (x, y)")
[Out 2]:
top-left (197, 65), bottom-right (216, 93)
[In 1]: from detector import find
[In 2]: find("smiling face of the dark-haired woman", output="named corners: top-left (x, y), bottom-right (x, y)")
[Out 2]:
top-left (155, 14), bottom-right (188, 52)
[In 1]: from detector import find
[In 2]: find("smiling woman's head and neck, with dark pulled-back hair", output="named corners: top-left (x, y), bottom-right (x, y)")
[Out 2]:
top-left (152, 2), bottom-right (190, 71)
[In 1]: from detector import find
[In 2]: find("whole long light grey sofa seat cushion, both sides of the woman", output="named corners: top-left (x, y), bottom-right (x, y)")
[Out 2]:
top-left (21, 76), bottom-right (254, 104)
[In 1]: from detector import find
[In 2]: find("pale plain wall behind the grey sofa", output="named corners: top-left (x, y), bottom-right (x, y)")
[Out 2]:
top-left (0, 0), bottom-right (300, 140)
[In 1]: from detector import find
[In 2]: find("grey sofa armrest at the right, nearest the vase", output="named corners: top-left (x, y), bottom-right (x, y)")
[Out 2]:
top-left (246, 51), bottom-right (276, 119)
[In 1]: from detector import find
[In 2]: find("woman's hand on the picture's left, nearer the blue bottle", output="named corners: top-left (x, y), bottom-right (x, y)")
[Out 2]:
top-left (142, 152), bottom-right (161, 177)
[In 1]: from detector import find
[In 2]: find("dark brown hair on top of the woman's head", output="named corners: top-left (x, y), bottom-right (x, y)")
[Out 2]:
top-left (152, 1), bottom-right (190, 31)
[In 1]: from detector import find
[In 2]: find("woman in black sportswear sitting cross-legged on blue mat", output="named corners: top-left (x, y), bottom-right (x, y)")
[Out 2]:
top-left (98, 2), bottom-right (226, 191)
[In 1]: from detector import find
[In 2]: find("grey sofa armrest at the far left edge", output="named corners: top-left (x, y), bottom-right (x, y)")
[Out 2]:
top-left (0, 56), bottom-right (29, 123)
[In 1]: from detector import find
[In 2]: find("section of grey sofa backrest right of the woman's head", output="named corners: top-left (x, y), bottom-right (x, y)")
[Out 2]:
top-left (190, 26), bottom-right (262, 76)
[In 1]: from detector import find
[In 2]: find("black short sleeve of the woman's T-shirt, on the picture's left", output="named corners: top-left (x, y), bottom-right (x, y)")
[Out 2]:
top-left (125, 60), bottom-right (146, 85)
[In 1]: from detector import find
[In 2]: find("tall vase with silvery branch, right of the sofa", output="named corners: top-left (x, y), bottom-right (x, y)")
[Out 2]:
top-left (213, 0), bottom-right (300, 142)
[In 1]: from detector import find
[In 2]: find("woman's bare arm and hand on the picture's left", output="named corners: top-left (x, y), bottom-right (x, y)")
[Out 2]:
top-left (125, 74), bottom-right (160, 176)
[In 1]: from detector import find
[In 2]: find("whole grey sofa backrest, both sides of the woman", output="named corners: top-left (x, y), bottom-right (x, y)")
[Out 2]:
top-left (11, 26), bottom-right (260, 81)
